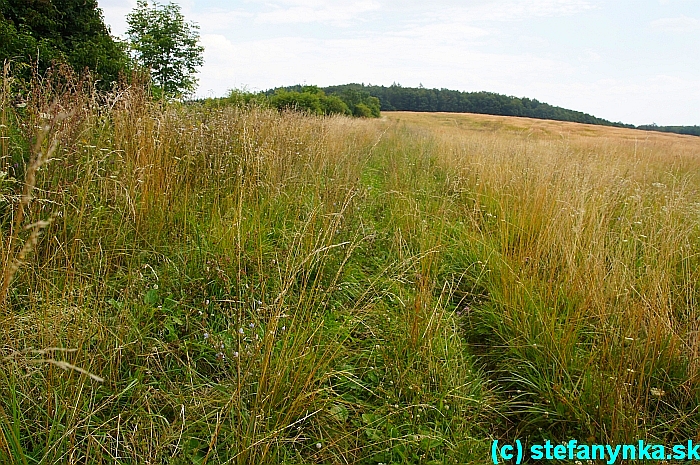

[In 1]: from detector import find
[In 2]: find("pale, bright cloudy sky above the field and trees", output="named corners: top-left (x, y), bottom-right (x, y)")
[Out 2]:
top-left (98, 0), bottom-right (700, 125)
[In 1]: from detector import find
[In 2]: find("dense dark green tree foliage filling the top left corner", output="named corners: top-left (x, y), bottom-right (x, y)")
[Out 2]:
top-left (0, 0), bottom-right (129, 87)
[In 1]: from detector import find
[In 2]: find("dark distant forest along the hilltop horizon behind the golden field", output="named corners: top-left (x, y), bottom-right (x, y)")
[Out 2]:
top-left (304, 84), bottom-right (700, 136)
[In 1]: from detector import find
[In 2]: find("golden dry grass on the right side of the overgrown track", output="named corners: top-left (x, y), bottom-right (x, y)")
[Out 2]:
top-left (390, 114), bottom-right (700, 441)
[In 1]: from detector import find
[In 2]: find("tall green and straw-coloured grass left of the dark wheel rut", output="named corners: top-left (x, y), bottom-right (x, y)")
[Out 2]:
top-left (0, 70), bottom-right (492, 464)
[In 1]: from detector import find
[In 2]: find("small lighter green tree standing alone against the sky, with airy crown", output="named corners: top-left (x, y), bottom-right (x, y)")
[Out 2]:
top-left (126, 0), bottom-right (204, 97)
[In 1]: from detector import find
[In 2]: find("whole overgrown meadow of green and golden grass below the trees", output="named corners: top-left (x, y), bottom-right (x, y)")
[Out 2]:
top-left (0, 81), bottom-right (700, 464)
